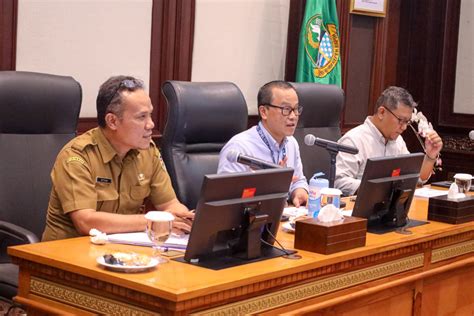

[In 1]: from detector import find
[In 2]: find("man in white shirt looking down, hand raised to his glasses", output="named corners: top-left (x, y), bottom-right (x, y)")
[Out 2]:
top-left (335, 87), bottom-right (443, 195)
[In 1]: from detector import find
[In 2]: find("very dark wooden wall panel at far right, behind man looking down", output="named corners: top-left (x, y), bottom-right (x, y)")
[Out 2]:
top-left (398, 0), bottom-right (474, 180)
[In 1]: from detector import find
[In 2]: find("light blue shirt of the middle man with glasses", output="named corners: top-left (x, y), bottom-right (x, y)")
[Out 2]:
top-left (217, 123), bottom-right (308, 192)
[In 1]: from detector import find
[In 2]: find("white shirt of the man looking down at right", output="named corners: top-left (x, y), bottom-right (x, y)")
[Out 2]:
top-left (334, 117), bottom-right (410, 195)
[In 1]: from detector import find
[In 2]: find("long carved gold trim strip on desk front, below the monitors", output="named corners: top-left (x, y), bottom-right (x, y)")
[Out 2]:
top-left (192, 254), bottom-right (424, 315)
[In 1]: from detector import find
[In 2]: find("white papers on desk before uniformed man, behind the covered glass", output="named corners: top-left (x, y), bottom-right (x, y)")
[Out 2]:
top-left (107, 232), bottom-right (189, 249)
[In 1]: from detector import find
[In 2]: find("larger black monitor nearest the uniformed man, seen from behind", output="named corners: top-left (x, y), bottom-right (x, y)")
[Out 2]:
top-left (177, 168), bottom-right (293, 270)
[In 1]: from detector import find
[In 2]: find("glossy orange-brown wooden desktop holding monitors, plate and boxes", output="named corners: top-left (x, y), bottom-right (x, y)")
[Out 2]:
top-left (9, 195), bottom-right (474, 311)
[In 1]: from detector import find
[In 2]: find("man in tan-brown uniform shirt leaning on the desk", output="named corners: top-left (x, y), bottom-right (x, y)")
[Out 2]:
top-left (43, 76), bottom-right (194, 241)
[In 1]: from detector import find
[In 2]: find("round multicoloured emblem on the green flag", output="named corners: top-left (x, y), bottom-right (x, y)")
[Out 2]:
top-left (304, 14), bottom-right (340, 78)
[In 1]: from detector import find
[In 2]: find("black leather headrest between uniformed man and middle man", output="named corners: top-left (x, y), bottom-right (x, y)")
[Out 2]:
top-left (162, 81), bottom-right (248, 144)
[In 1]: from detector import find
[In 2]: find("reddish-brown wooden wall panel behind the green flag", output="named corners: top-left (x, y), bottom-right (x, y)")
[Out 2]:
top-left (285, 0), bottom-right (402, 131)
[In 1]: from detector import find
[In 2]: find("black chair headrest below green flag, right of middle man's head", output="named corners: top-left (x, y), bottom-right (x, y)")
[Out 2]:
top-left (291, 82), bottom-right (344, 127)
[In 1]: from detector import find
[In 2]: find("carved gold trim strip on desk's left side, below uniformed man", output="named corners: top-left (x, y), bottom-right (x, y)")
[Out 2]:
top-left (30, 277), bottom-right (160, 315)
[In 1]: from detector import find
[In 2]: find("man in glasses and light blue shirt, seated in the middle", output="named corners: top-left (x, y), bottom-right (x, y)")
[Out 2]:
top-left (218, 81), bottom-right (308, 207)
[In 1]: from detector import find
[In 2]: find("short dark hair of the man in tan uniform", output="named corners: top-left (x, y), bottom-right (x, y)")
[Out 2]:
top-left (96, 76), bottom-right (145, 127)
